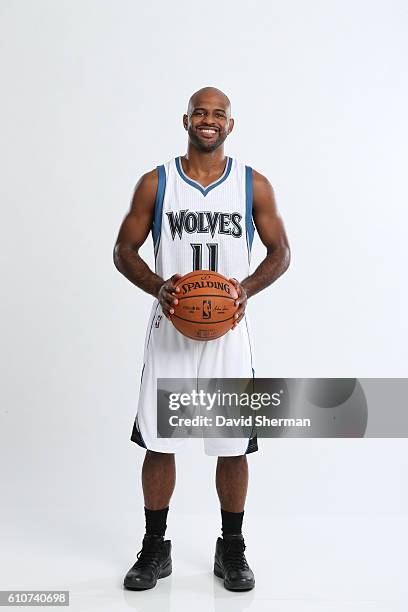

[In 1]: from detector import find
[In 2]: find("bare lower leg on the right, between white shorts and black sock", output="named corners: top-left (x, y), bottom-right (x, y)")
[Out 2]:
top-left (216, 455), bottom-right (248, 512)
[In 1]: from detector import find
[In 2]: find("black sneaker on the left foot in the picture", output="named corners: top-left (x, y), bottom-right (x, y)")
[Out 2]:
top-left (123, 534), bottom-right (172, 591)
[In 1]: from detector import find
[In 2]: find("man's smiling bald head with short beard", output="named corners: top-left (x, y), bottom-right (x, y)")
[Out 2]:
top-left (183, 87), bottom-right (234, 153)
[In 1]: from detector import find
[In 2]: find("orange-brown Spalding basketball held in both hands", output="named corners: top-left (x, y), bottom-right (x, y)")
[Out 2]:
top-left (171, 270), bottom-right (238, 340)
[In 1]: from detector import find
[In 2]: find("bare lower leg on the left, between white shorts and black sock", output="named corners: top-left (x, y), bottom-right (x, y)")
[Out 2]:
top-left (142, 450), bottom-right (176, 510)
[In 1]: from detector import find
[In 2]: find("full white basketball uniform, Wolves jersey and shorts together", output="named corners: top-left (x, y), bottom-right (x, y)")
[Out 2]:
top-left (131, 157), bottom-right (258, 457)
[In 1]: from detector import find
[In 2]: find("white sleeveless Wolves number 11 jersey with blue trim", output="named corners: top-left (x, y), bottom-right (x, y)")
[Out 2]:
top-left (152, 157), bottom-right (254, 281)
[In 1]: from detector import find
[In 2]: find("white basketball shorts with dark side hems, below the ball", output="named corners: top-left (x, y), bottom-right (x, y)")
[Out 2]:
top-left (131, 300), bottom-right (258, 456)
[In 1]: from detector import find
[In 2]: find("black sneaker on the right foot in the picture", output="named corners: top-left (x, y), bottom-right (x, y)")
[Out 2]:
top-left (214, 534), bottom-right (255, 591)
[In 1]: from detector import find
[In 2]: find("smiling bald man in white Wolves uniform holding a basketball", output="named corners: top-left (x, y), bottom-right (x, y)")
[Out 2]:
top-left (114, 87), bottom-right (290, 591)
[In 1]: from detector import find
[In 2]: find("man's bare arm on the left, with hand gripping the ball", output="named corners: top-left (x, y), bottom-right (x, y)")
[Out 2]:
top-left (113, 170), bottom-right (179, 316)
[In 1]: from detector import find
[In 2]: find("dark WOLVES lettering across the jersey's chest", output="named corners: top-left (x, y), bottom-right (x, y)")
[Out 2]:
top-left (166, 209), bottom-right (242, 240)
